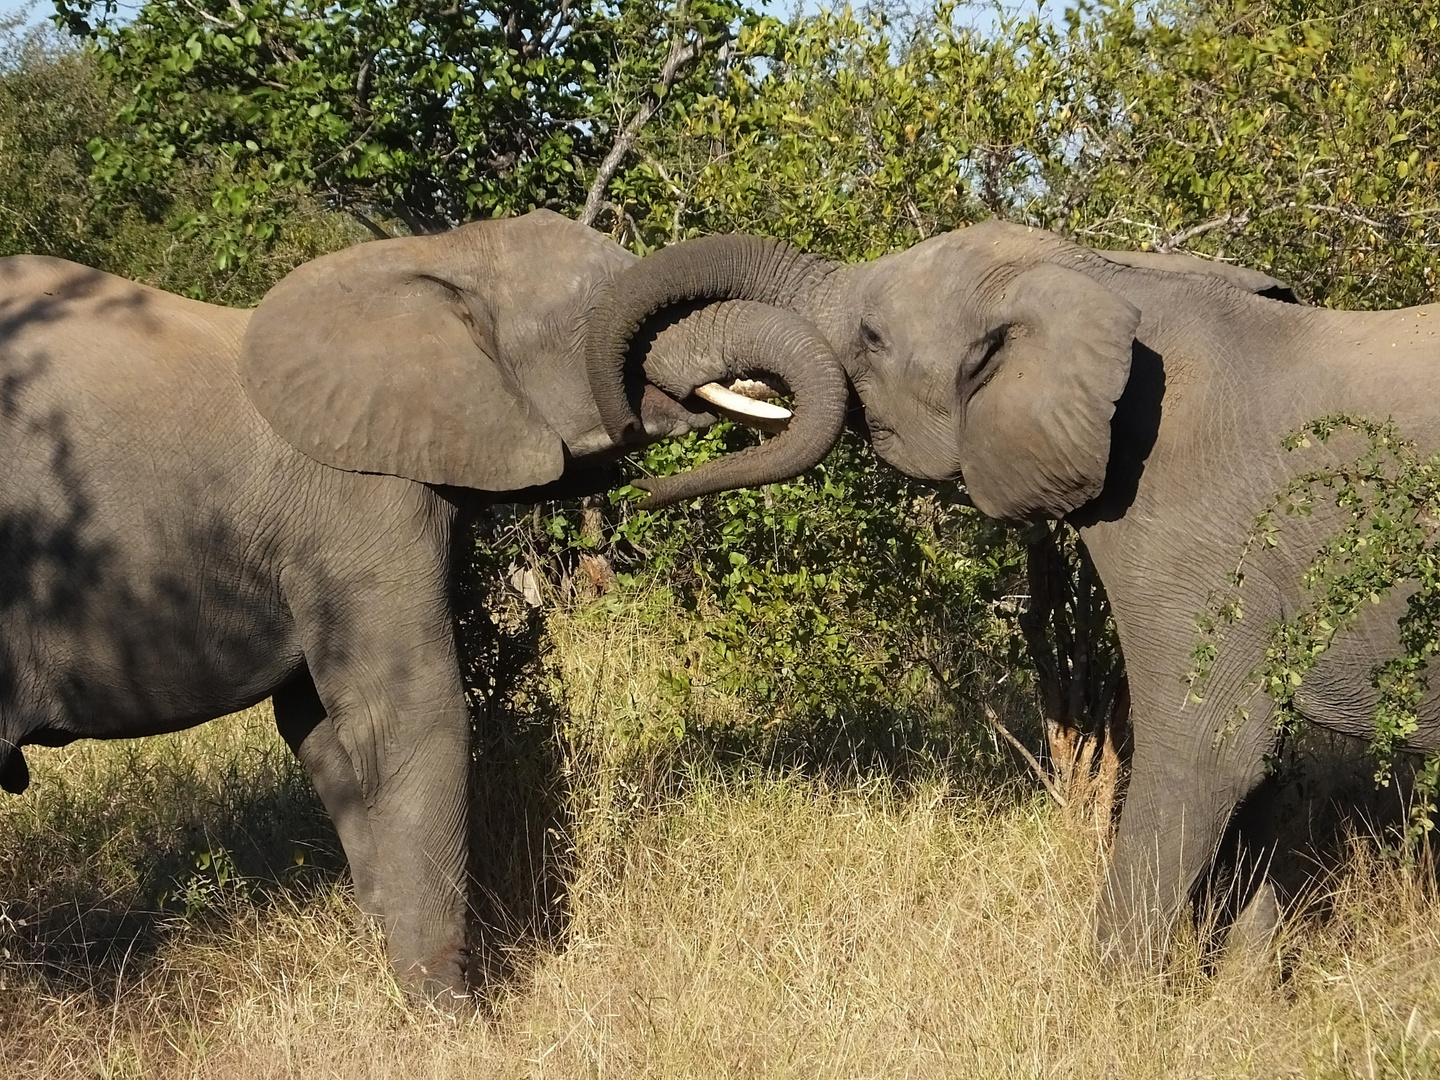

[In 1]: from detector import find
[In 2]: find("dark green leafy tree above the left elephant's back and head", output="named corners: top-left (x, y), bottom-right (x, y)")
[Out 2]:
top-left (59, 0), bottom-right (740, 265)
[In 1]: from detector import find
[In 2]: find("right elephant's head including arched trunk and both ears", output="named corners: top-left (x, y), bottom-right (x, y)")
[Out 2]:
top-left (589, 222), bottom-right (1293, 521)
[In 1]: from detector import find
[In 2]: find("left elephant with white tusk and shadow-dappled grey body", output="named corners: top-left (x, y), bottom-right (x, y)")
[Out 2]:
top-left (0, 210), bottom-right (848, 999)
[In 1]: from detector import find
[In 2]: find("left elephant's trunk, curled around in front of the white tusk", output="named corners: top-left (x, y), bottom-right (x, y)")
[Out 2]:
top-left (635, 301), bottom-right (848, 510)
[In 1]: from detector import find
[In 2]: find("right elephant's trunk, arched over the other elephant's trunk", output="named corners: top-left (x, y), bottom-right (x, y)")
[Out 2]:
top-left (585, 235), bottom-right (831, 442)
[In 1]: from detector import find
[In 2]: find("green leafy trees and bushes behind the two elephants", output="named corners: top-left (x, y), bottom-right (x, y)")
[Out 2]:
top-left (8, 0), bottom-right (1440, 794)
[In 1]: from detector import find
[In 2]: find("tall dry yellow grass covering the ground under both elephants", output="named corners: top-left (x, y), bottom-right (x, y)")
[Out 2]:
top-left (0, 587), bottom-right (1440, 1080)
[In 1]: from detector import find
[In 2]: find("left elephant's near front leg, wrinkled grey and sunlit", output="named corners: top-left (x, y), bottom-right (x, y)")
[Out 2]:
top-left (292, 566), bottom-right (469, 998)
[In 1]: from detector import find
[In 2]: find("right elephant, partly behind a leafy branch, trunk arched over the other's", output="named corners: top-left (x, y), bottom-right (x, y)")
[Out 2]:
top-left (590, 220), bottom-right (1440, 968)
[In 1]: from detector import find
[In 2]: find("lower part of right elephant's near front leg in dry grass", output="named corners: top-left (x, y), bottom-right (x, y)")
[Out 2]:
top-left (1096, 696), bottom-right (1267, 969)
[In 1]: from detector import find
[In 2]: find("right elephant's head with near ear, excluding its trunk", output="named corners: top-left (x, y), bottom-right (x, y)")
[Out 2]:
top-left (806, 222), bottom-right (1140, 521)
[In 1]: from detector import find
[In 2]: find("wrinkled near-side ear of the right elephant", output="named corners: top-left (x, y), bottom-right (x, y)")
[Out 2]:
top-left (960, 264), bottom-right (1140, 521)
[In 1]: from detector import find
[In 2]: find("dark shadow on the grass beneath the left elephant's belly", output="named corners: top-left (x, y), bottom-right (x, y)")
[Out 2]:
top-left (0, 710), bottom-right (346, 995)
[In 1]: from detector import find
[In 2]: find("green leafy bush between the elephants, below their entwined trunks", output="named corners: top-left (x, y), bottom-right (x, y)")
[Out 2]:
top-left (482, 423), bottom-right (1022, 732)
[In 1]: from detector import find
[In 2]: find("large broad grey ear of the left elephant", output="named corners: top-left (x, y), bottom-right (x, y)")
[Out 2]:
top-left (240, 236), bottom-right (564, 491)
